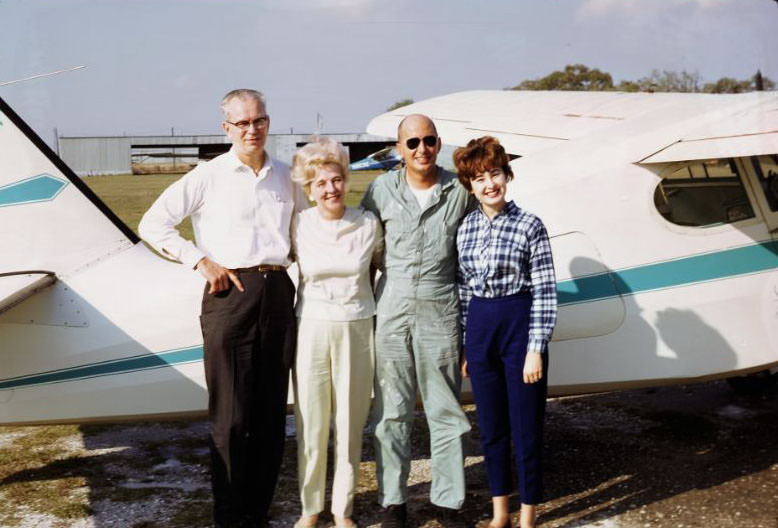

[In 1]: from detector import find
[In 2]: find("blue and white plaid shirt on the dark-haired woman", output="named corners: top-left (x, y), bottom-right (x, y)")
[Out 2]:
top-left (457, 201), bottom-right (557, 353)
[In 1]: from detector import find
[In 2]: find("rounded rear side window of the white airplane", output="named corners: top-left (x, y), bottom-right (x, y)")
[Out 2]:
top-left (654, 159), bottom-right (756, 227)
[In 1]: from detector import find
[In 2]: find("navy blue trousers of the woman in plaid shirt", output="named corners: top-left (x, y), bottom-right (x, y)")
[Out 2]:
top-left (465, 294), bottom-right (548, 504)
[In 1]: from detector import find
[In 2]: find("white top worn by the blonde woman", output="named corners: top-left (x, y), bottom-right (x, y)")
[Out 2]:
top-left (292, 207), bottom-right (384, 321)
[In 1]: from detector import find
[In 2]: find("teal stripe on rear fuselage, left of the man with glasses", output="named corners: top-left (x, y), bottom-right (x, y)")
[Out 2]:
top-left (0, 345), bottom-right (203, 390)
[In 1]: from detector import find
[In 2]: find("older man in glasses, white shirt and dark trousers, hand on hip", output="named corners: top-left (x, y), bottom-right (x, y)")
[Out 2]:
top-left (139, 90), bottom-right (307, 528)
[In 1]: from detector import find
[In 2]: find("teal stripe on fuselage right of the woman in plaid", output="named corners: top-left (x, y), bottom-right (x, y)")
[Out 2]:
top-left (557, 241), bottom-right (778, 305)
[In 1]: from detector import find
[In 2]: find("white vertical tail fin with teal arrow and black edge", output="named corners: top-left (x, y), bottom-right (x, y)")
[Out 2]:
top-left (0, 99), bottom-right (138, 306)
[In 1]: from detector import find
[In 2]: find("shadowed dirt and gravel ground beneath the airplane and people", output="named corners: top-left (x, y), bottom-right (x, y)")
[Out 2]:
top-left (0, 382), bottom-right (778, 528)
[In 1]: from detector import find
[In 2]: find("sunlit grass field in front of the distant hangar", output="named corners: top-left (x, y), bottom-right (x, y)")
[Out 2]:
top-left (84, 171), bottom-right (381, 240)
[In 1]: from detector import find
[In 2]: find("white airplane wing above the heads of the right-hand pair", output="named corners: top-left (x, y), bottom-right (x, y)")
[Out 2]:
top-left (367, 90), bottom-right (778, 162)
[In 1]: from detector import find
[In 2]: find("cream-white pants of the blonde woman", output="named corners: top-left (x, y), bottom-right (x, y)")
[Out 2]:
top-left (293, 318), bottom-right (375, 517)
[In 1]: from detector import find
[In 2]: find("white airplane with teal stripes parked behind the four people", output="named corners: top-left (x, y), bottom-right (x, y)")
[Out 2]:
top-left (0, 91), bottom-right (778, 424)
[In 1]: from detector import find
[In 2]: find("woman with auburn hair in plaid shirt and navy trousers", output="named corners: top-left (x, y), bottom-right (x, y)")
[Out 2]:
top-left (454, 136), bottom-right (557, 528)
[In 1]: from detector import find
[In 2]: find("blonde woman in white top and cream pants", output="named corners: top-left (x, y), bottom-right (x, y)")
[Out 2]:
top-left (292, 138), bottom-right (383, 528)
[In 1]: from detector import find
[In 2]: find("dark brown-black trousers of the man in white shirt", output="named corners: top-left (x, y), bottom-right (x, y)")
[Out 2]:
top-left (200, 271), bottom-right (296, 526)
